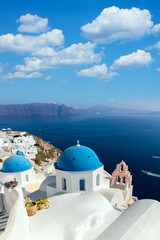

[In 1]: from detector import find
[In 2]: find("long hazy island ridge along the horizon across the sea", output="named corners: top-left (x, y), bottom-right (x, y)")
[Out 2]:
top-left (0, 103), bottom-right (151, 117)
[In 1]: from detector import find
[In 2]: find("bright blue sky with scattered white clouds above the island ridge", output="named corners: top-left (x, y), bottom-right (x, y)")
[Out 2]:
top-left (0, 0), bottom-right (160, 110)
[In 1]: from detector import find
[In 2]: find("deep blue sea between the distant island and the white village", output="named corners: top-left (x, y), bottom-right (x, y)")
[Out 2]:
top-left (0, 115), bottom-right (160, 201)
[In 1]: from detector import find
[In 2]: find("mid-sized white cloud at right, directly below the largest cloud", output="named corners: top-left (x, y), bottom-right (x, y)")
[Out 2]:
top-left (110, 49), bottom-right (153, 70)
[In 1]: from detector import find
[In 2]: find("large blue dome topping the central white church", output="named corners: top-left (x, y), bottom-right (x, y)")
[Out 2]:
top-left (56, 146), bottom-right (103, 172)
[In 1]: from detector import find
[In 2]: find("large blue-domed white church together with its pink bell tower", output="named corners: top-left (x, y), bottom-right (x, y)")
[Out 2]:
top-left (42, 141), bottom-right (133, 207)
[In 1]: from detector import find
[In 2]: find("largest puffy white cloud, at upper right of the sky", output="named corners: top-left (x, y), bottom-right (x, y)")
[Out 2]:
top-left (81, 6), bottom-right (159, 44)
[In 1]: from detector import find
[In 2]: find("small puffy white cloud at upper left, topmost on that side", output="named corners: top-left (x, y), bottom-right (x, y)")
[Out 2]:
top-left (16, 13), bottom-right (49, 33)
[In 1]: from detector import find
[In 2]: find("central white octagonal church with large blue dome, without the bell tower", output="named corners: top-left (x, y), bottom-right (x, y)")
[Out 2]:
top-left (55, 141), bottom-right (109, 192)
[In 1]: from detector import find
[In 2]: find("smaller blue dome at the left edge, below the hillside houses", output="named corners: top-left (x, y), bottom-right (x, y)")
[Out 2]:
top-left (2, 151), bottom-right (32, 173)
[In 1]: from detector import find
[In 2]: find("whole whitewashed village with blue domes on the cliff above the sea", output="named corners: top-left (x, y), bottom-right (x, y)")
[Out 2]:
top-left (0, 129), bottom-right (160, 240)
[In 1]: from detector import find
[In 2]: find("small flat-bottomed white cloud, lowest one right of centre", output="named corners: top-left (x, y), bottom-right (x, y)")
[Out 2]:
top-left (77, 64), bottom-right (118, 81)
